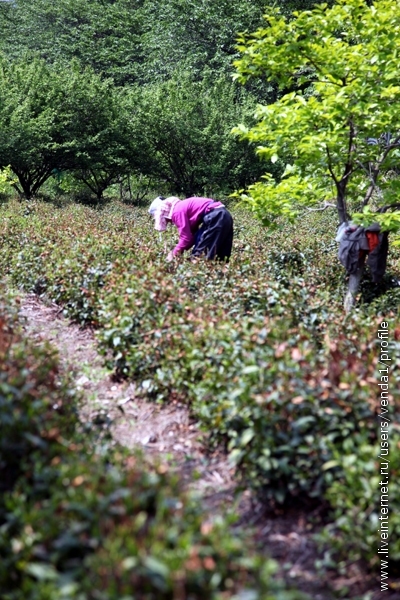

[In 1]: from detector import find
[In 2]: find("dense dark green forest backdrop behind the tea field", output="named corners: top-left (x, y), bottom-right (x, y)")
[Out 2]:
top-left (0, 0), bottom-right (324, 200)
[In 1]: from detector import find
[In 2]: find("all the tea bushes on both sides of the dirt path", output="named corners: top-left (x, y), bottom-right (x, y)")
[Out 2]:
top-left (0, 201), bottom-right (400, 600)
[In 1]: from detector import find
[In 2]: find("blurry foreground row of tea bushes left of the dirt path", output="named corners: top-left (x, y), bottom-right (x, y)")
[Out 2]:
top-left (0, 289), bottom-right (304, 600)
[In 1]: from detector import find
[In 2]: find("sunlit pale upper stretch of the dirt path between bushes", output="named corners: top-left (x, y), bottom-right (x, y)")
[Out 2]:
top-left (21, 294), bottom-right (235, 508)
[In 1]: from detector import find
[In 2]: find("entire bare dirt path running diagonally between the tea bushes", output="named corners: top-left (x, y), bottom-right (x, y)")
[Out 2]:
top-left (21, 294), bottom-right (400, 600)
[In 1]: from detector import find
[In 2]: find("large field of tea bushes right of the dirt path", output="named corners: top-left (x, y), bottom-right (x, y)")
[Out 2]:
top-left (0, 199), bottom-right (400, 576)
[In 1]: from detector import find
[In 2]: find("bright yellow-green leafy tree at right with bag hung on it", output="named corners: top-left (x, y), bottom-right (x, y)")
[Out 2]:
top-left (236, 0), bottom-right (400, 230)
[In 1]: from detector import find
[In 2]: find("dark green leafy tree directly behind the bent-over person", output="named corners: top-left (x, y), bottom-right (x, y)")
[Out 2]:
top-left (135, 75), bottom-right (261, 195)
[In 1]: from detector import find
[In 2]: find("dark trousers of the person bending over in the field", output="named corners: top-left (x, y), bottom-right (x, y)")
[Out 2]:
top-left (192, 206), bottom-right (233, 261)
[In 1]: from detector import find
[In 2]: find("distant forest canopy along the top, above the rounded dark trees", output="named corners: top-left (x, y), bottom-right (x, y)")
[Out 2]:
top-left (0, 0), bottom-right (332, 86)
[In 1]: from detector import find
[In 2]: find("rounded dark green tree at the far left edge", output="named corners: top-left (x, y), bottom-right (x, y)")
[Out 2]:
top-left (0, 59), bottom-right (139, 198)
